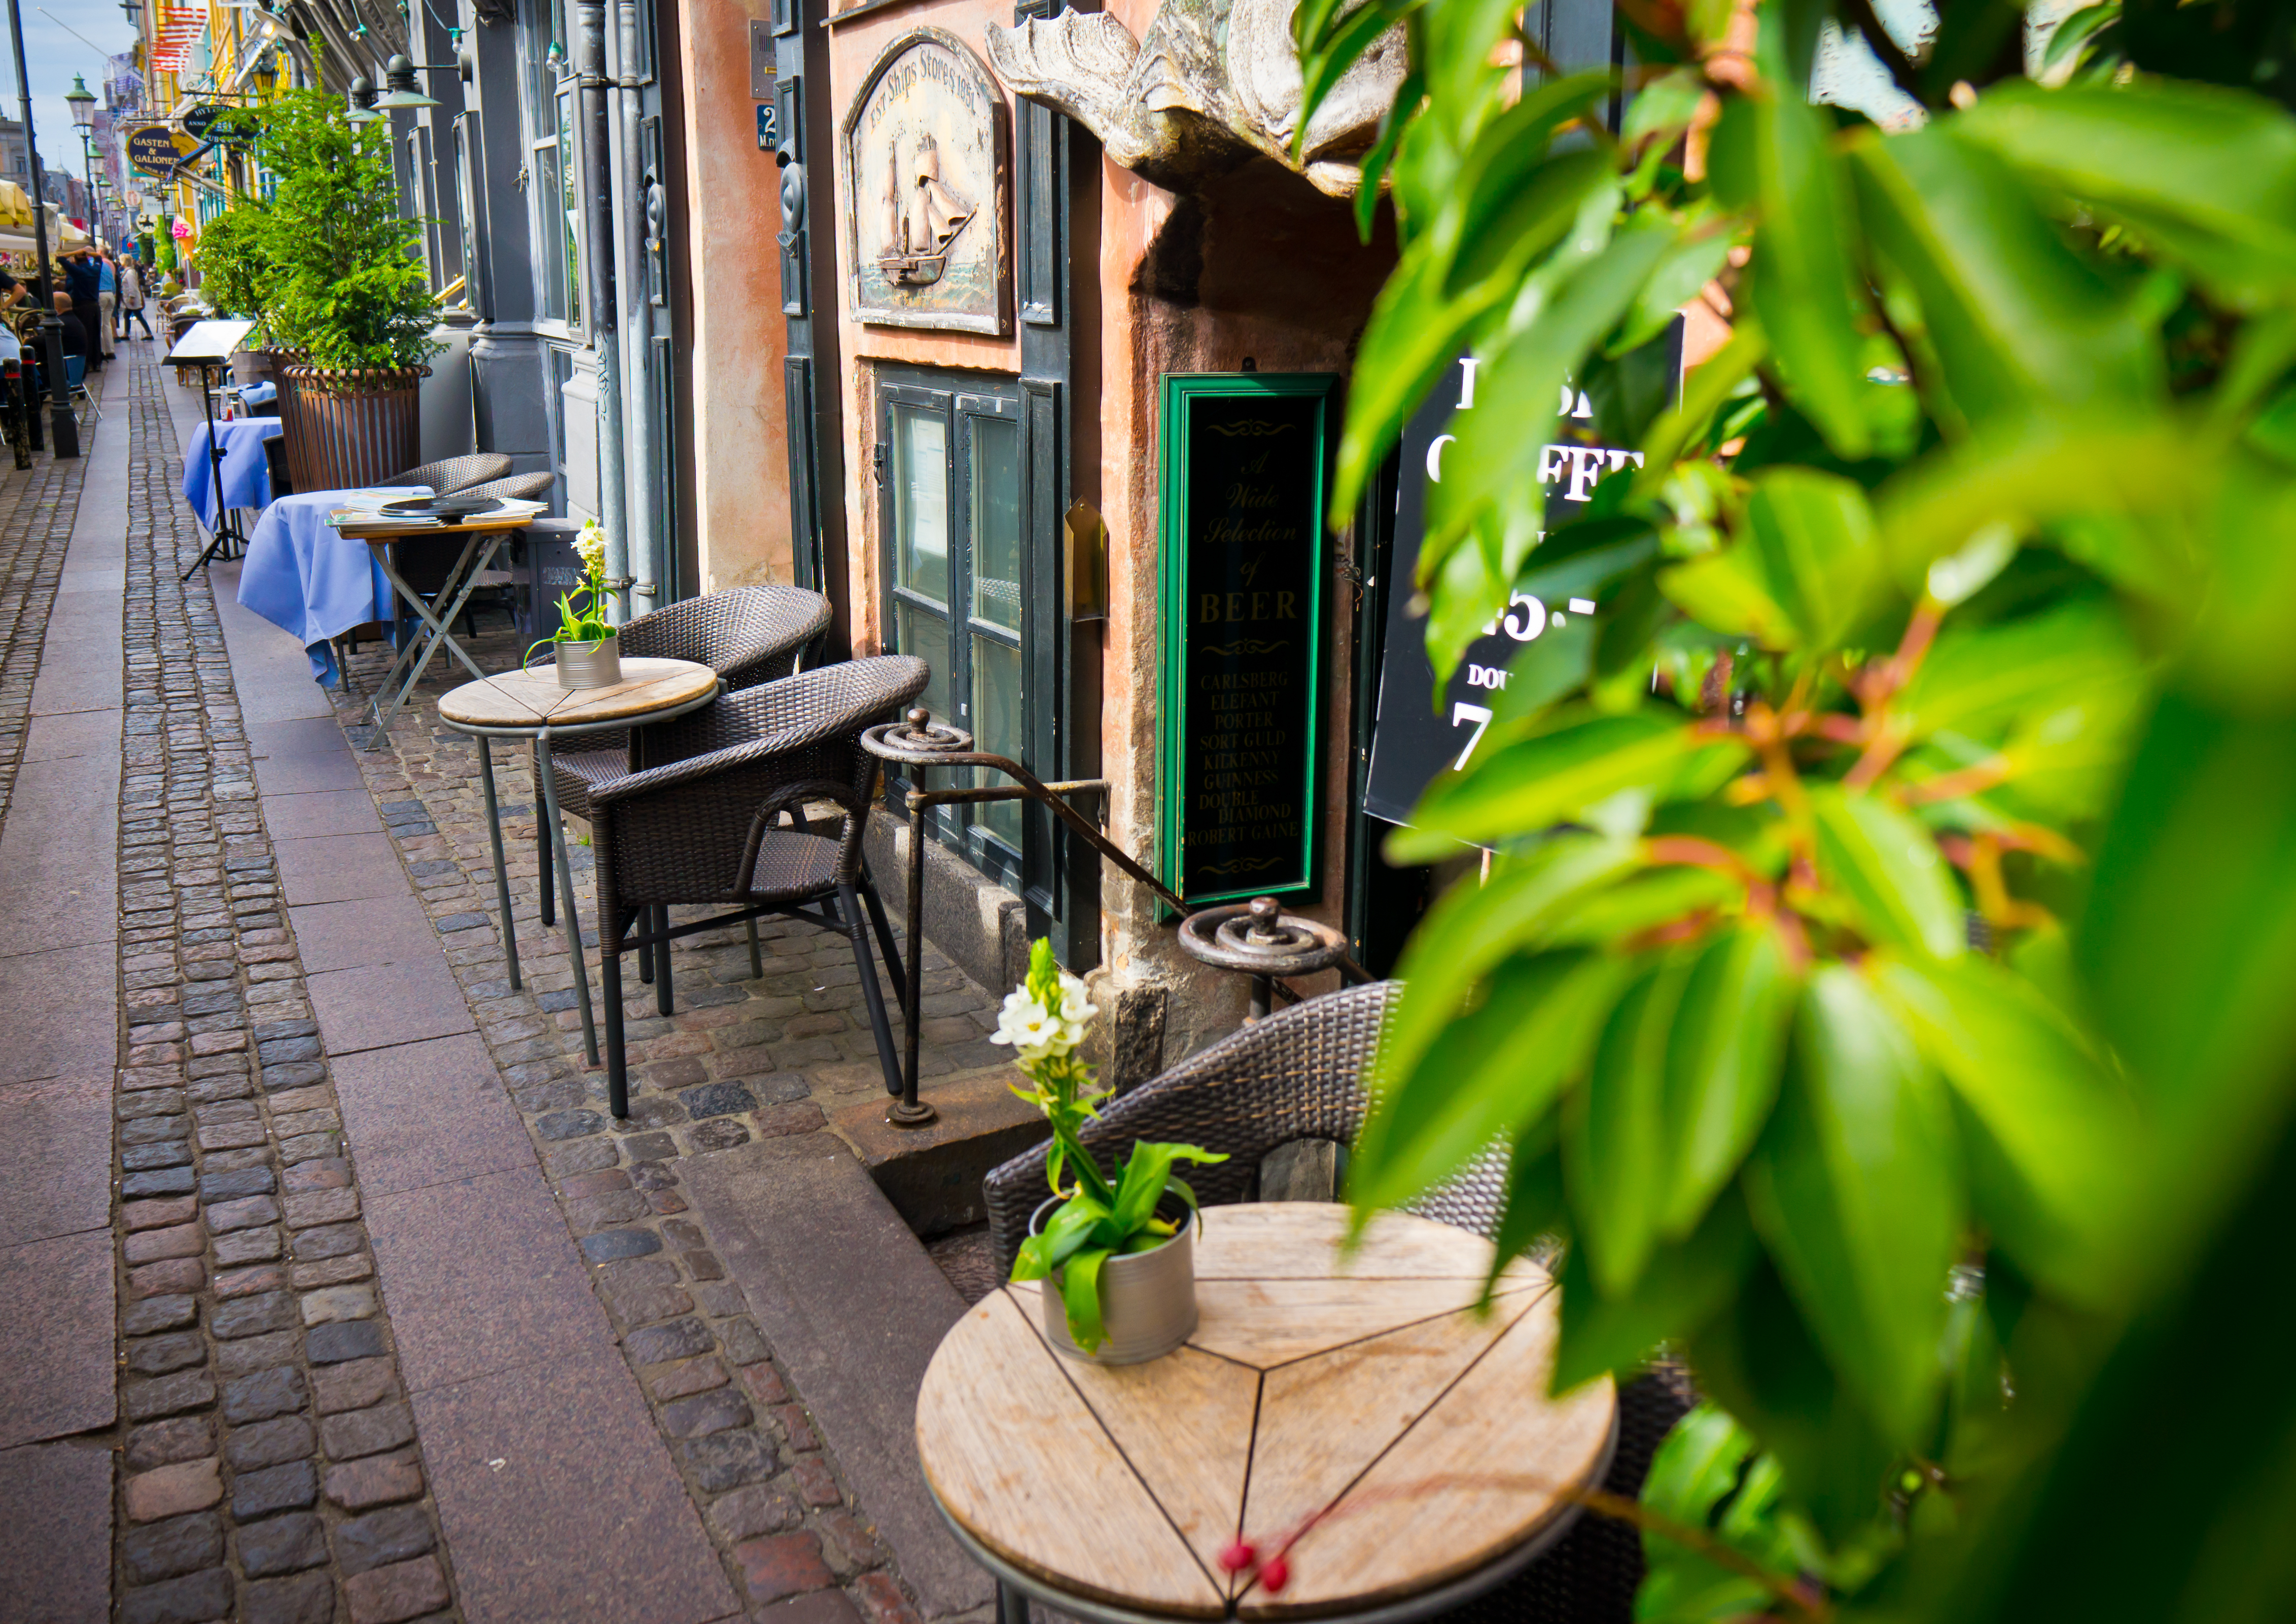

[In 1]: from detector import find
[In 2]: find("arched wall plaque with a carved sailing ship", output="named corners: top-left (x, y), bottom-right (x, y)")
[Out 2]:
top-left (842, 27), bottom-right (1010, 335)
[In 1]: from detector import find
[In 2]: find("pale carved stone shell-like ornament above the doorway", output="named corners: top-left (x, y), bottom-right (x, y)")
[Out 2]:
top-left (987, 0), bottom-right (1407, 197)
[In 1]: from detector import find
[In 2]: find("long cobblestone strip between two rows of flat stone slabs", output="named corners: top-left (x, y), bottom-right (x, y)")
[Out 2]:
top-left (110, 351), bottom-right (459, 1624)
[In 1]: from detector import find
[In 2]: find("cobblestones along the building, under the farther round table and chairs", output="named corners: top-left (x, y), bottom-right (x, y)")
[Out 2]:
top-left (316, 616), bottom-right (1010, 1624)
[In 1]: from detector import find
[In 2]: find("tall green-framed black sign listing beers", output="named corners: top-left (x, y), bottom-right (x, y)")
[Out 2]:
top-left (1159, 372), bottom-right (1338, 903)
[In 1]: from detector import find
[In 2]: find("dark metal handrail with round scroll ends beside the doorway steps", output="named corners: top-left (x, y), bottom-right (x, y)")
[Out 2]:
top-left (861, 710), bottom-right (1371, 1128)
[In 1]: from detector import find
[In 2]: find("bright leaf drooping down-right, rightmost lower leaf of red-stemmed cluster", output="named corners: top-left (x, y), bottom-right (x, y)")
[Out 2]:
top-left (1866, 956), bottom-right (2144, 1307)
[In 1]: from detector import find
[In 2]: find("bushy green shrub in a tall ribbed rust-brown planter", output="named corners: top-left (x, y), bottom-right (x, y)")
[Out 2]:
top-left (257, 90), bottom-right (439, 489)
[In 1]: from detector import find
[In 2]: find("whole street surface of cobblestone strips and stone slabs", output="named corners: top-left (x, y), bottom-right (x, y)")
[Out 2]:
top-left (0, 342), bottom-right (1024, 1624)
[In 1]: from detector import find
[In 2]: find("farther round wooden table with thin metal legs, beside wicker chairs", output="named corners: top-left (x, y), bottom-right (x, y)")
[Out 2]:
top-left (439, 657), bottom-right (723, 1079)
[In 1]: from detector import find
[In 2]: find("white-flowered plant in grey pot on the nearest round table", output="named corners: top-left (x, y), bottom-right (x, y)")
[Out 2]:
top-left (990, 939), bottom-right (1228, 1364)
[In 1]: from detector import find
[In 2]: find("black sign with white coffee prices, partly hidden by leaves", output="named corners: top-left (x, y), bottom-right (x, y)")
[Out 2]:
top-left (1364, 317), bottom-right (1683, 822)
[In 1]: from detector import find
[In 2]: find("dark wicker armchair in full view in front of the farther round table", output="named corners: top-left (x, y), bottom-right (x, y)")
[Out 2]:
top-left (588, 655), bottom-right (928, 1116)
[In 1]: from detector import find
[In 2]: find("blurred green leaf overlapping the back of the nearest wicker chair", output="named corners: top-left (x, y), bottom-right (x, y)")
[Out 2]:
top-left (1348, 954), bottom-right (1633, 1213)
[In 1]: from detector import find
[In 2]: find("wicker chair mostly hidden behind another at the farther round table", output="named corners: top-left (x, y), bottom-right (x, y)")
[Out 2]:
top-left (535, 586), bottom-right (829, 1015)
